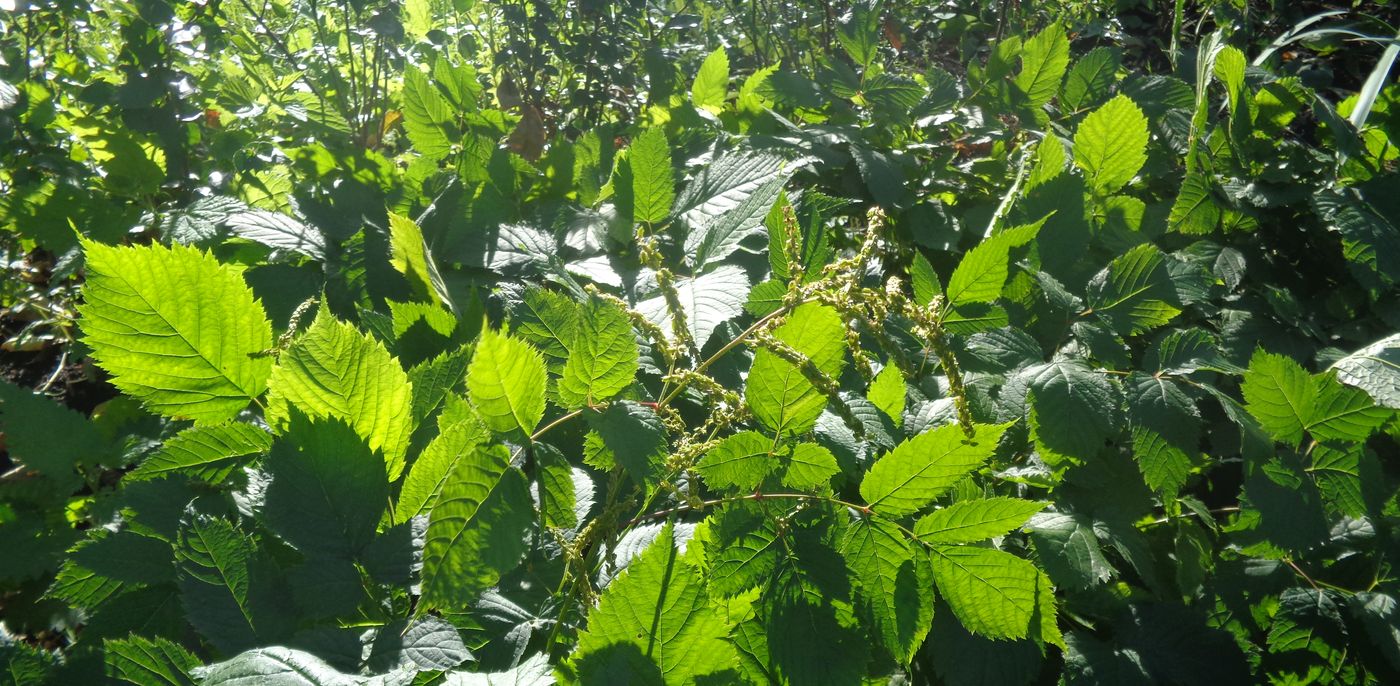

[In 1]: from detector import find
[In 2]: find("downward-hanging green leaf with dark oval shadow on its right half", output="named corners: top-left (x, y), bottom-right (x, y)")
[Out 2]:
top-left (841, 517), bottom-right (934, 664)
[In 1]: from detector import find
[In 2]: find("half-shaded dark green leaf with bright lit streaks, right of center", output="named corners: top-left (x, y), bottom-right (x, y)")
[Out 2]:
top-left (1088, 244), bottom-right (1180, 336)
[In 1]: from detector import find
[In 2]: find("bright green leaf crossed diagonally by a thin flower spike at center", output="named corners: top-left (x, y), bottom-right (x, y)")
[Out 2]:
top-left (743, 302), bottom-right (846, 435)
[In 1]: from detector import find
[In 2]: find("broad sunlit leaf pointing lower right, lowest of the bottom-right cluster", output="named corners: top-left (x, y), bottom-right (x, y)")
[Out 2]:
top-left (930, 546), bottom-right (1039, 638)
